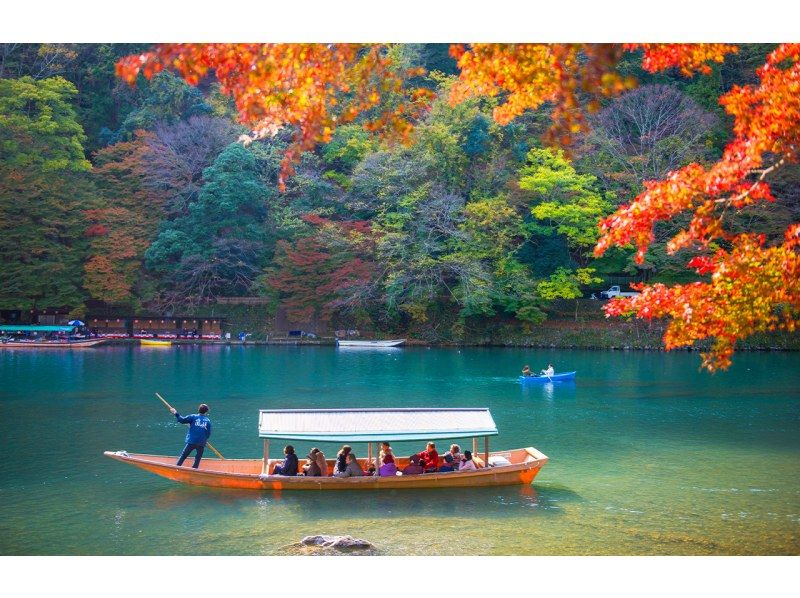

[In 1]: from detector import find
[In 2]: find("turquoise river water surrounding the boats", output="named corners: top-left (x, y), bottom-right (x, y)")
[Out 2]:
top-left (0, 346), bottom-right (800, 555)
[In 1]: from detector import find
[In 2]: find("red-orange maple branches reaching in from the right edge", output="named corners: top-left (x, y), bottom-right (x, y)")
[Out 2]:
top-left (595, 44), bottom-right (800, 370)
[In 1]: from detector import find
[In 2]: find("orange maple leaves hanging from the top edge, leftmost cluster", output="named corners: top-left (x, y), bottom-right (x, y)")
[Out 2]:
top-left (117, 44), bottom-right (430, 190)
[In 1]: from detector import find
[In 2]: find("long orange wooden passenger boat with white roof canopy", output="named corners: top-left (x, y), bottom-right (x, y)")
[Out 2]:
top-left (104, 408), bottom-right (548, 491)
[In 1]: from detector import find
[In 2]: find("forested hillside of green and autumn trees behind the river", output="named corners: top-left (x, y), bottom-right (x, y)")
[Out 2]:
top-left (0, 44), bottom-right (800, 346)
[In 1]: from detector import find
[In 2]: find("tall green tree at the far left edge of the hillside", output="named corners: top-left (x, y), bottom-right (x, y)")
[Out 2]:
top-left (0, 76), bottom-right (94, 308)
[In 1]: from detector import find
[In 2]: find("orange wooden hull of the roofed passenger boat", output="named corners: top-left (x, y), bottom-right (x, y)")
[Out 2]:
top-left (104, 447), bottom-right (548, 491)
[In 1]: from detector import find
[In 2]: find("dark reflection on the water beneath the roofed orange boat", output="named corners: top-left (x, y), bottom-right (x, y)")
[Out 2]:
top-left (147, 484), bottom-right (584, 519)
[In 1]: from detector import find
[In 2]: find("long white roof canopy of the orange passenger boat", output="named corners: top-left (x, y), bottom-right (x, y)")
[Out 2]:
top-left (258, 407), bottom-right (497, 442)
